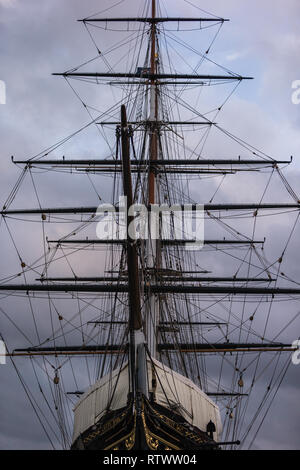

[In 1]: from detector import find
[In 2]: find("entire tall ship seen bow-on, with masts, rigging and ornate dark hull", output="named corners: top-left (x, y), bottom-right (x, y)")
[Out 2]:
top-left (0, 0), bottom-right (300, 451)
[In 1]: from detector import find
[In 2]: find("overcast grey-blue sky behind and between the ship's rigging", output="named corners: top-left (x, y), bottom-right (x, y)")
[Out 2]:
top-left (0, 0), bottom-right (300, 449)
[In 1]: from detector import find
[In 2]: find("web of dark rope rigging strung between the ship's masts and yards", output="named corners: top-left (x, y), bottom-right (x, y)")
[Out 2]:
top-left (0, 0), bottom-right (300, 449)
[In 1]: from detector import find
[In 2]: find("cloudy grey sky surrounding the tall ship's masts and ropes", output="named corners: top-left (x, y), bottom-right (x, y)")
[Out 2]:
top-left (0, 0), bottom-right (300, 449)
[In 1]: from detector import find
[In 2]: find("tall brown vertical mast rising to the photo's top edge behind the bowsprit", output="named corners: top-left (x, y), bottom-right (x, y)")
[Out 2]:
top-left (145, 0), bottom-right (158, 357)
